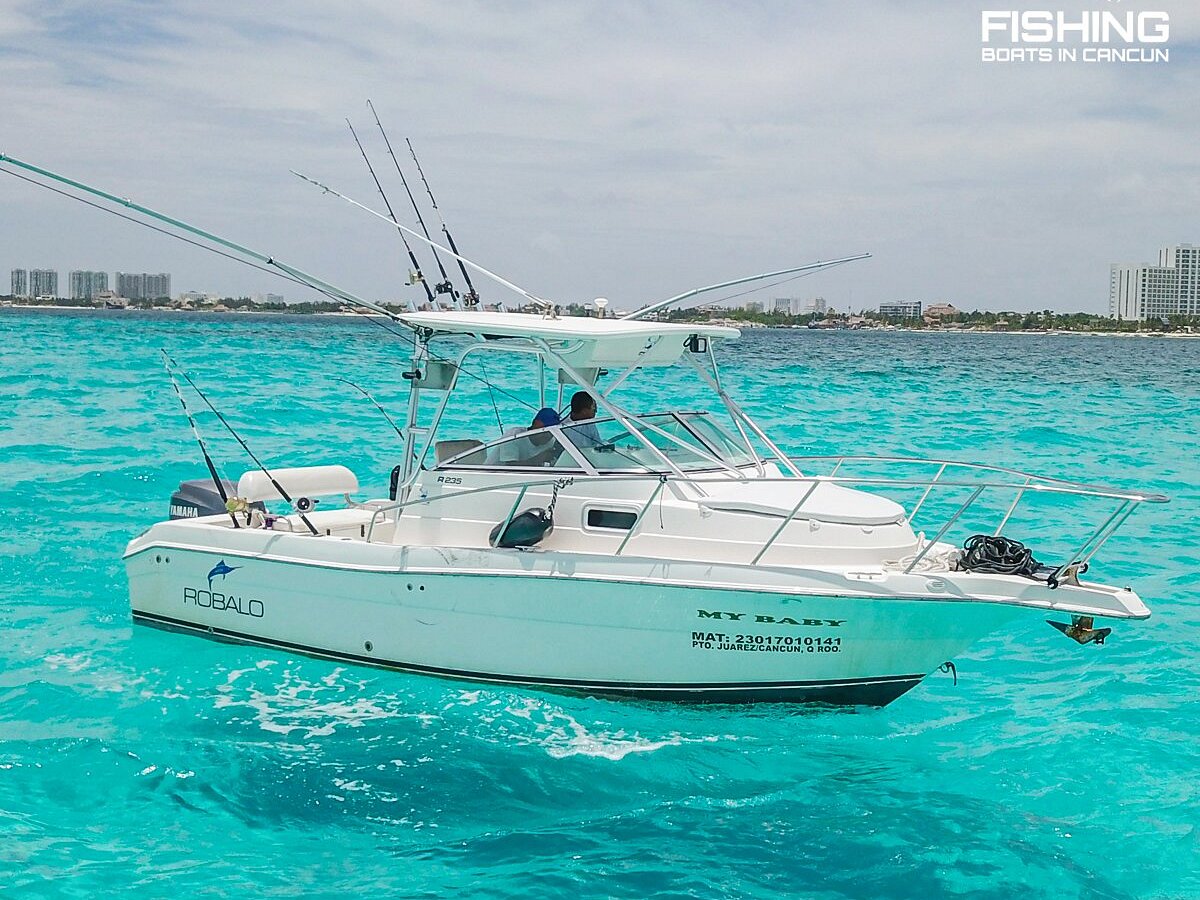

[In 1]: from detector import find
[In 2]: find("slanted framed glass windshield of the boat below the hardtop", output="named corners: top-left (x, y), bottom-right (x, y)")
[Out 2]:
top-left (438, 413), bottom-right (754, 472)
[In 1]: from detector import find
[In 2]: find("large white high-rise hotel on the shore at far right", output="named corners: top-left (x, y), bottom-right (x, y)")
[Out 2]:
top-left (1109, 244), bottom-right (1200, 322)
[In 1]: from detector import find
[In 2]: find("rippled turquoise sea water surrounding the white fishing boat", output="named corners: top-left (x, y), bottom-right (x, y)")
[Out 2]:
top-left (0, 310), bottom-right (1200, 898)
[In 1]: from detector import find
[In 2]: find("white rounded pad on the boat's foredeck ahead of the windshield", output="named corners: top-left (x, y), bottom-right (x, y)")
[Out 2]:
top-left (696, 480), bottom-right (906, 526)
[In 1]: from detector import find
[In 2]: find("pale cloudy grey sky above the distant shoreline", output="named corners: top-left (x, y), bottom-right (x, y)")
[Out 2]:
top-left (0, 0), bottom-right (1200, 312)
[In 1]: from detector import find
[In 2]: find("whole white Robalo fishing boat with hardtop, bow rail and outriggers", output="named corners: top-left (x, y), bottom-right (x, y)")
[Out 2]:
top-left (0, 156), bottom-right (1165, 704)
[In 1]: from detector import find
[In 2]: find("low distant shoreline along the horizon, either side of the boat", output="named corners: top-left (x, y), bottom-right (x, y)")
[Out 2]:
top-left (0, 304), bottom-right (1200, 340)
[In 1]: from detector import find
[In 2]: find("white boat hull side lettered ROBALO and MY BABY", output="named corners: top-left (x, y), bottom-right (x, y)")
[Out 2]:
top-left (126, 546), bottom-right (1030, 706)
